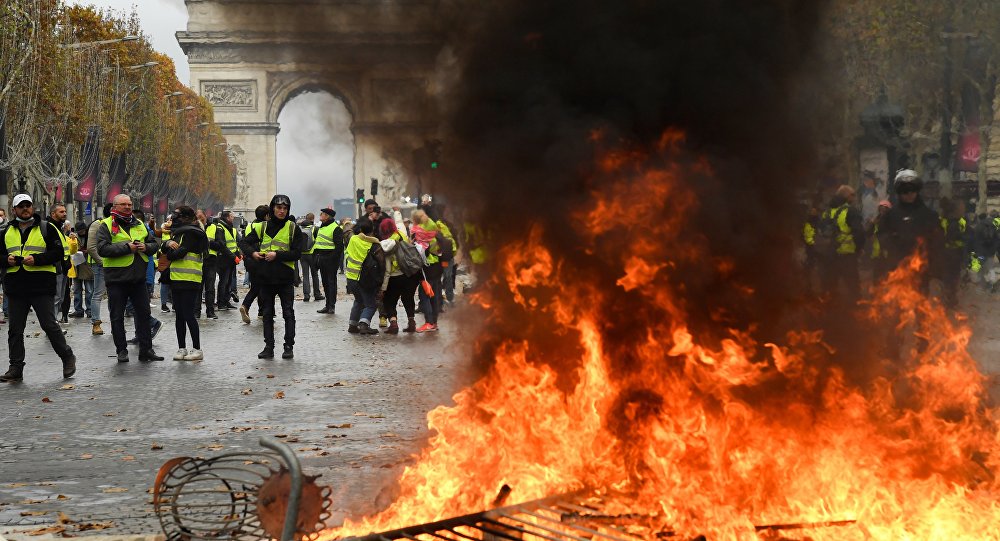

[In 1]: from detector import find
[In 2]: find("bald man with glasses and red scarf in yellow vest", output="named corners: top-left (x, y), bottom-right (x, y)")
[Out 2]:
top-left (97, 194), bottom-right (163, 363)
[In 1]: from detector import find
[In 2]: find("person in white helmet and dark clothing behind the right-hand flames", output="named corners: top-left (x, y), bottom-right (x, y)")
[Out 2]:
top-left (878, 169), bottom-right (943, 290)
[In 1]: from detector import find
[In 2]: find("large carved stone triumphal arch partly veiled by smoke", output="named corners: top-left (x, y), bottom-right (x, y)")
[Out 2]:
top-left (177, 0), bottom-right (441, 209)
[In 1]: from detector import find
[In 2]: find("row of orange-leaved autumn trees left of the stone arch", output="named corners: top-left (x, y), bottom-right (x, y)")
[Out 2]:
top-left (0, 0), bottom-right (235, 211)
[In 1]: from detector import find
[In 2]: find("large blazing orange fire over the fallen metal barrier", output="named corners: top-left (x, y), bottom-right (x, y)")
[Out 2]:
top-left (327, 132), bottom-right (1000, 540)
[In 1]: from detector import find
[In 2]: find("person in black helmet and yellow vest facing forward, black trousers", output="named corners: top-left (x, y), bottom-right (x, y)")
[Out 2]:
top-left (240, 194), bottom-right (302, 359)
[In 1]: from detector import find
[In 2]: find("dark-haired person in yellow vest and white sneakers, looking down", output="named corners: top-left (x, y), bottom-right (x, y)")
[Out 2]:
top-left (162, 206), bottom-right (208, 361)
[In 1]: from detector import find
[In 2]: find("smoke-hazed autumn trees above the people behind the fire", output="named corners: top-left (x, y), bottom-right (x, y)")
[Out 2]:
top-left (817, 0), bottom-right (1000, 210)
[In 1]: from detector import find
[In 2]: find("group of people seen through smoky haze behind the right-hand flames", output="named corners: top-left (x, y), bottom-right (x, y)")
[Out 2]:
top-left (802, 169), bottom-right (1000, 308)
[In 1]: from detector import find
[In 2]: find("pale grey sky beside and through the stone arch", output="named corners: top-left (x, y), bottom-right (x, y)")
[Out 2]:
top-left (67, 0), bottom-right (354, 209)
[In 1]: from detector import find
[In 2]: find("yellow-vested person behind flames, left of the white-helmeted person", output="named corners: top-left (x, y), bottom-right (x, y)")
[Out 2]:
top-left (820, 185), bottom-right (865, 304)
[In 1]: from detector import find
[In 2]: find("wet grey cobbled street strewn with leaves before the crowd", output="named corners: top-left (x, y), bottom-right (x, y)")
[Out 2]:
top-left (0, 280), bottom-right (475, 539)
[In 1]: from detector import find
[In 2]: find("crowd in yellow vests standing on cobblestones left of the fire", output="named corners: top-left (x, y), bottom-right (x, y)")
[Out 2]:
top-left (0, 194), bottom-right (485, 382)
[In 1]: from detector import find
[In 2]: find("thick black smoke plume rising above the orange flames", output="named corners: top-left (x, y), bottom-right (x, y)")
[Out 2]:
top-left (441, 0), bottom-right (822, 360)
